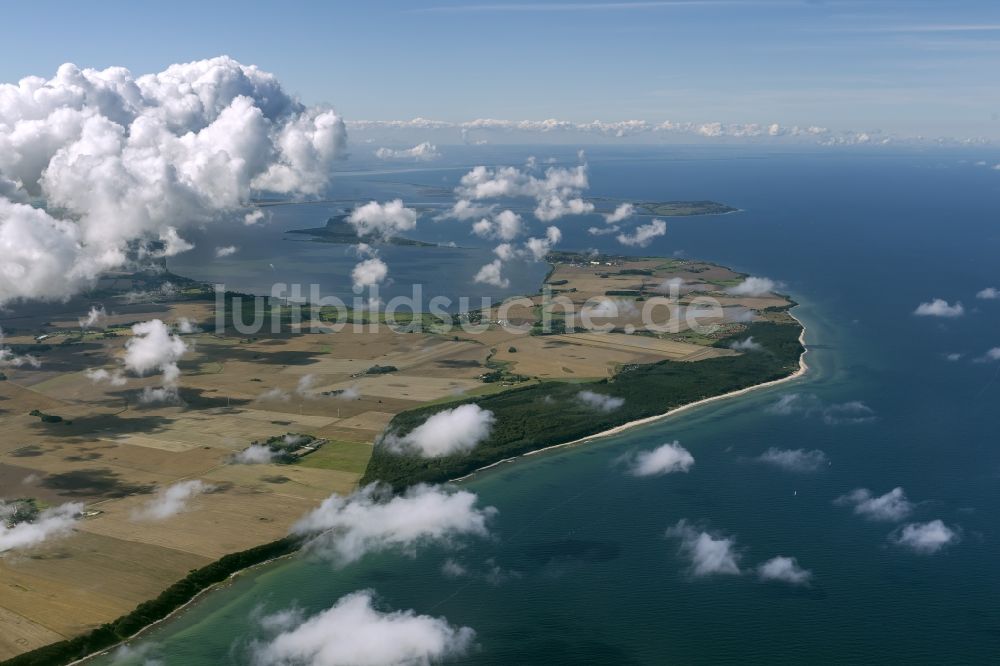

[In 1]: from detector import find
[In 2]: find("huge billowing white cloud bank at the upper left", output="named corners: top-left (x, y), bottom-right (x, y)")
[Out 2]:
top-left (0, 57), bottom-right (347, 303)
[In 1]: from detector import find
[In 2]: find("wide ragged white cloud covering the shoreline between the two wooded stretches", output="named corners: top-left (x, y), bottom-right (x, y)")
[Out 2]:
top-left (292, 484), bottom-right (496, 565)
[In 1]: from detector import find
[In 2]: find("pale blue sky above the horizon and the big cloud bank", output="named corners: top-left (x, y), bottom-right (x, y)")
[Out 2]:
top-left (0, 0), bottom-right (1000, 138)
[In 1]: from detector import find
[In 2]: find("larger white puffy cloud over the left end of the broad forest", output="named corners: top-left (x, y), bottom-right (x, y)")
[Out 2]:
top-left (383, 404), bottom-right (496, 458)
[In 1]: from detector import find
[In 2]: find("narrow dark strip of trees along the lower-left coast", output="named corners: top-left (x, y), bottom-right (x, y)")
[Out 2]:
top-left (0, 537), bottom-right (299, 666)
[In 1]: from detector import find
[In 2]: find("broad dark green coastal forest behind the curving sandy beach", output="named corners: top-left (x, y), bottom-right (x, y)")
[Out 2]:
top-left (361, 322), bottom-right (804, 489)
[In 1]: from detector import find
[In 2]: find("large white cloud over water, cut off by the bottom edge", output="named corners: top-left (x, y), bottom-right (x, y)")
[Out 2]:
top-left (252, 590), bottom-right (475, 666)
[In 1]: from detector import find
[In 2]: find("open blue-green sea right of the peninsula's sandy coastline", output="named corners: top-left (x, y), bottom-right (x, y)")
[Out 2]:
top-left (92, 149), bottom-right (1000, 665)
